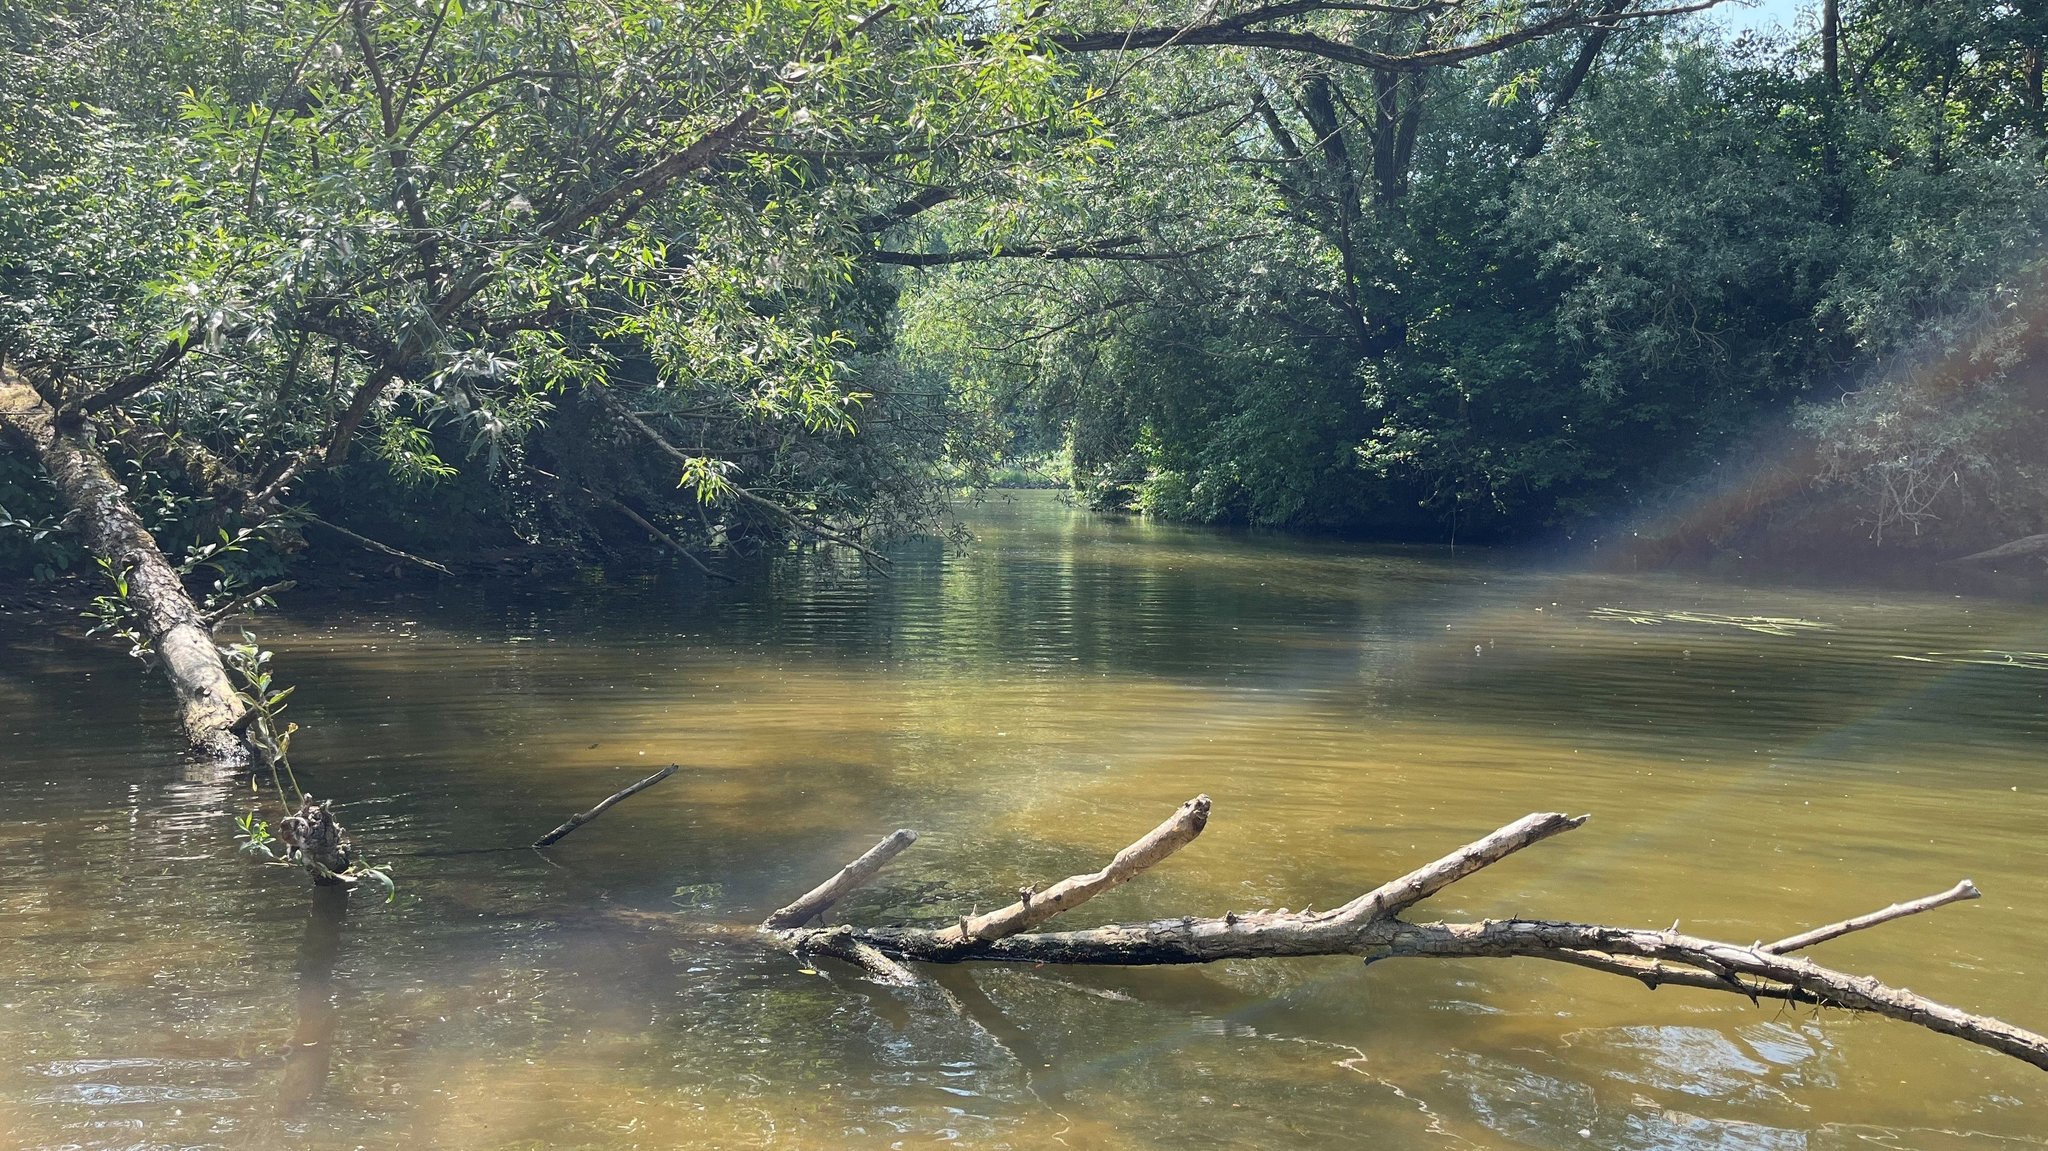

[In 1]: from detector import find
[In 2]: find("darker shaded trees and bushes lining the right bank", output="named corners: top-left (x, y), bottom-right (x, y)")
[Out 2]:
top-left (909, 2), bottom-right (2048, 543)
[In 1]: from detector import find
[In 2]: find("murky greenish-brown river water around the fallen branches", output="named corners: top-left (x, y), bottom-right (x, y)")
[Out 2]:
top-left (0, 498), bottom-right (2048, 1151)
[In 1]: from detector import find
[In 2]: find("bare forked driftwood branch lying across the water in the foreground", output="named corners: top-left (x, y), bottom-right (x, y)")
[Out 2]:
top-left (762, 795), bottom-right (2048, 1071)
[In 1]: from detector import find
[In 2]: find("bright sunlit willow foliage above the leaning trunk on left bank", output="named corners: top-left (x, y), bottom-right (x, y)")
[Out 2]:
top-left (0, 0), bottom-right (1092, 573)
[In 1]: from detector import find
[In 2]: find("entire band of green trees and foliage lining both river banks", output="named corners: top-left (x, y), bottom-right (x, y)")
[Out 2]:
top-left (0, 0), bottom-right (2048, 576)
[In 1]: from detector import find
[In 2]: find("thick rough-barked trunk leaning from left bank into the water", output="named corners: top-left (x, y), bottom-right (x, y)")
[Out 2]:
top-left (0, 363), bottom-right (250, 768)
